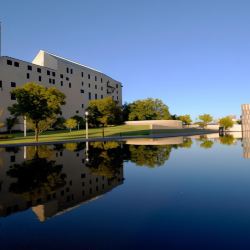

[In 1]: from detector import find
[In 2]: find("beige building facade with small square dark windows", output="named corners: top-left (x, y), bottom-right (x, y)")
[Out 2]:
top-left (0, 50), bottom-right (122, 130)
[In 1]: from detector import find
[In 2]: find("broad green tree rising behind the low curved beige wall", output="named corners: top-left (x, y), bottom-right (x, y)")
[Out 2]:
top-left (129, 98), bottom-right (171, 121)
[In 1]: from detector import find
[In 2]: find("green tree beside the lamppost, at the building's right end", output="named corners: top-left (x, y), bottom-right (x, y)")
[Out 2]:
top-left (88, 97), bottom-right (122, 127)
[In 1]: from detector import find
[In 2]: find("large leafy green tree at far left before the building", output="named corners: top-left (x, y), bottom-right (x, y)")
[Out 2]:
top-left (8, 82), bottom-right (65, 141)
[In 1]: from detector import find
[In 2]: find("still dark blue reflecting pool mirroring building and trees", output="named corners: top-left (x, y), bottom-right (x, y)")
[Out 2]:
top-left (0, 134), bottom-right (250, 249)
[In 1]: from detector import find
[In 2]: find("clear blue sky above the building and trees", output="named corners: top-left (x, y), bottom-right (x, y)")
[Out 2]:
top-left (0, 0), bottom-right (250, 117)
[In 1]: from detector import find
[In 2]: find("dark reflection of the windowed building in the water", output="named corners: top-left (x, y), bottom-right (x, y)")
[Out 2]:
top-left (0, 143), bottom-right (123, 221)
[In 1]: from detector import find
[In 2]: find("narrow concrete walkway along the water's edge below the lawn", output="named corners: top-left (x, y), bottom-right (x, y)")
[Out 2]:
top-left (0, 130), bottom-right (218, 148)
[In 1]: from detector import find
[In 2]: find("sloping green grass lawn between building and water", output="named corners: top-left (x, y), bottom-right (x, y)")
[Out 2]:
top-left (0, 125), bottom-right (215, 145)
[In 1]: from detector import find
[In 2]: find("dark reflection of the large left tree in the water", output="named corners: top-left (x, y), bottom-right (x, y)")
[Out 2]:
top-left (7, 146), bottom-right (66, 200)
